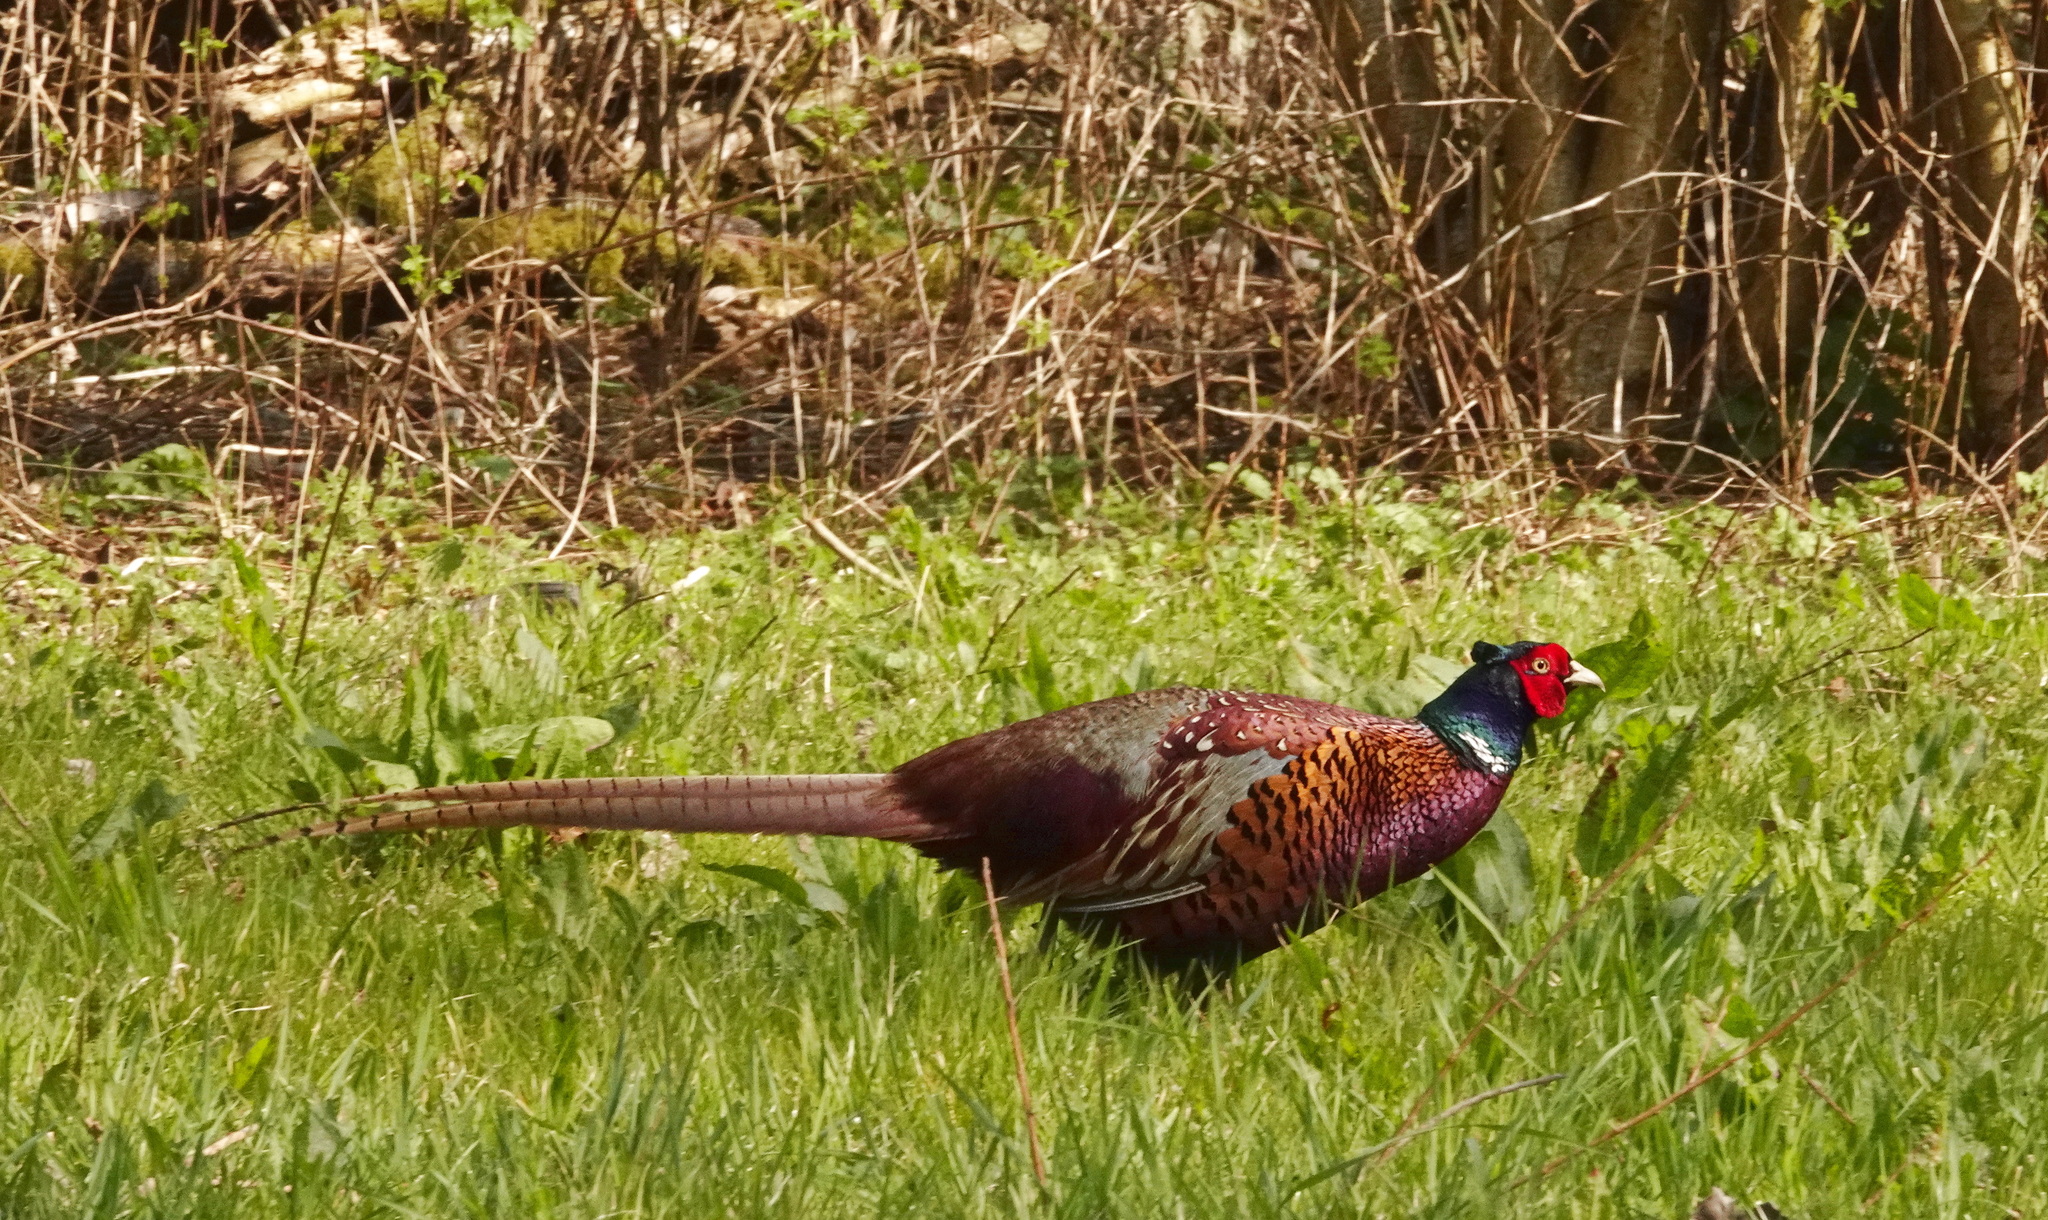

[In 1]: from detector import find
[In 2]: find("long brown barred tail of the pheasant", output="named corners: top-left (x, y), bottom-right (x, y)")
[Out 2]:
top-left (215, 776), bottom-right (946, 847)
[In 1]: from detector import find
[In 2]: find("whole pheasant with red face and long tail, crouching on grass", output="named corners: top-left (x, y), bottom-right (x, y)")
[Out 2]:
top-left (227, 641), bottom-right (1604, 964)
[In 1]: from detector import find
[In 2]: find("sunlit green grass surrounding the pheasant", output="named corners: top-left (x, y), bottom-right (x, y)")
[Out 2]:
top-left (0, 470), bottom-right (2048, 1218)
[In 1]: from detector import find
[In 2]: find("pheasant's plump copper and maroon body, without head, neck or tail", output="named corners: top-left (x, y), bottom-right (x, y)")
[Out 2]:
top-left (905, 688), bottom-right (1507, 958)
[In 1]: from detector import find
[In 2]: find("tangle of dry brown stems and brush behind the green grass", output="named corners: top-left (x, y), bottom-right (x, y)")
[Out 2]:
top-left (0, 0), bottom-right (2038, 530)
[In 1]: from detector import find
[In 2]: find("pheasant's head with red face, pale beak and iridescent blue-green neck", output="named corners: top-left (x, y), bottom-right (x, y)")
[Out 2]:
top-left (1417, 641), bottom-right (1604, 774)
